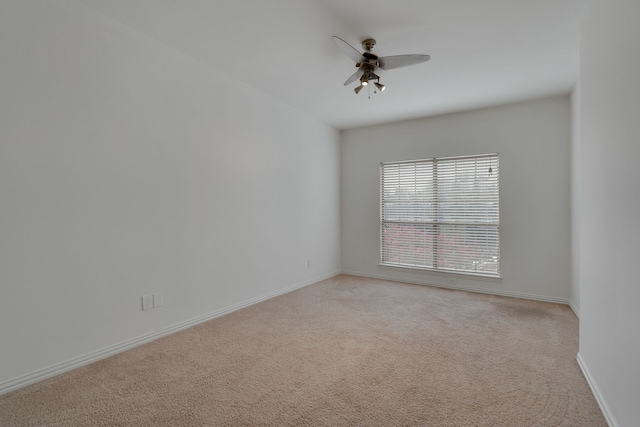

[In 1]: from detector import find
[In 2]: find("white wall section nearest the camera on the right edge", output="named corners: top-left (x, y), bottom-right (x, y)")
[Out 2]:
top-left (579, 0), bottom-right (640, 426)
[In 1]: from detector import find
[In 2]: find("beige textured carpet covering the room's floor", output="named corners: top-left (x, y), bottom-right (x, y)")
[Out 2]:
top-left (0, 276), bottom-right (606, 427)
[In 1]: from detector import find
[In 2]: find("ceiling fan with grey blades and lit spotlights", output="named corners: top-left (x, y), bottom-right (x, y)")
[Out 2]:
top-left (333, 36), bottom-right (431, 94)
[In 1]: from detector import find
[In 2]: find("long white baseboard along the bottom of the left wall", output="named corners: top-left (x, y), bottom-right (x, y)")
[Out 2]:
top-left (0, 271), bottom-right (341, 395)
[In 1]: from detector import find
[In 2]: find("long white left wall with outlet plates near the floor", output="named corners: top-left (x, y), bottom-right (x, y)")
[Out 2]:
top-left (0, 0), bottom-right (341, 392)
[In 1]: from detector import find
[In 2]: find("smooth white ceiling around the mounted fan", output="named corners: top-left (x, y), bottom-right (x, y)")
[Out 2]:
top-left (78, 0), bottom-right (585, 129)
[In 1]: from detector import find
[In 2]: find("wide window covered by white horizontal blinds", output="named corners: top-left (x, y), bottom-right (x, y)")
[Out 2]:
top-left (380, 154), bottom-right (500, 277)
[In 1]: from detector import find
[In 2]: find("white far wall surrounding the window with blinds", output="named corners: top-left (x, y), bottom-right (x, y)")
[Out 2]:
top-left (341, 96), bottom-right (571, 302)
